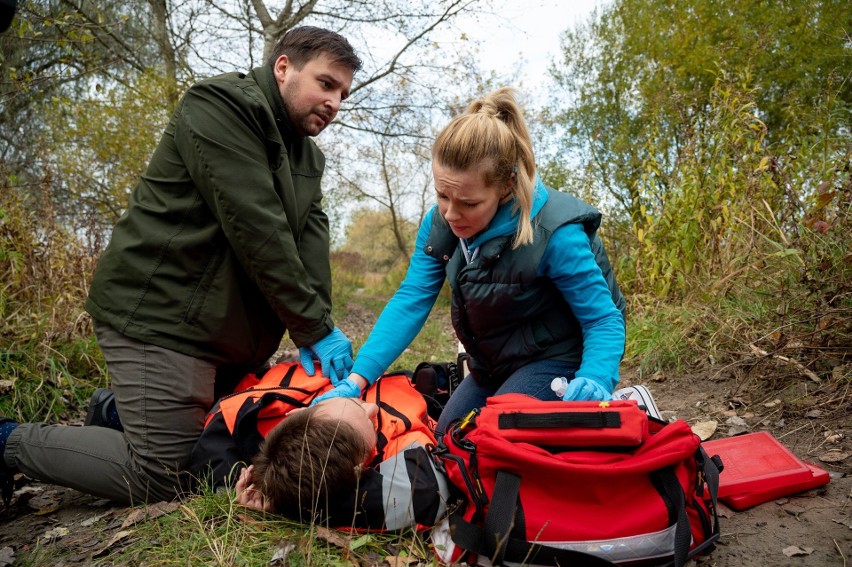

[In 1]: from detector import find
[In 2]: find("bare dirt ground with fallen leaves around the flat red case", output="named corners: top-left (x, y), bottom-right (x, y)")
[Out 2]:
top-left (622, 369), bottom-right (852, 567)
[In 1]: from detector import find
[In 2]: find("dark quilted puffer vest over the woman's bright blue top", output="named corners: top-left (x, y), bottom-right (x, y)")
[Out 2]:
top-left (425, 188), bottom-right (625, 386)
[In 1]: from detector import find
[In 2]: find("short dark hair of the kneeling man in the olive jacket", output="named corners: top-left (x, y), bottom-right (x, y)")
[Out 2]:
top-left (267, 26), bottom-right (361, 73)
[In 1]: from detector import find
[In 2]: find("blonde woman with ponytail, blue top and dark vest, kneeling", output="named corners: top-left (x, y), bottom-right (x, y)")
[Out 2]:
top-left (316, 88), bottom-right (625, 434)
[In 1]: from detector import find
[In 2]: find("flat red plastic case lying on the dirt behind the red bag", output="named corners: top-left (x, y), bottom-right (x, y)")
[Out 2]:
top-left (703, 431), bottom-right (829, 510)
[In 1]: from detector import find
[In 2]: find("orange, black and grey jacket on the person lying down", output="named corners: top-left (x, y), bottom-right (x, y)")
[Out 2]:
top-left (191, 362), bottom-right (449, 530)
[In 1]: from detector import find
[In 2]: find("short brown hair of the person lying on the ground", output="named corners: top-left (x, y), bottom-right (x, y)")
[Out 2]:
top-left (252, 406), bottom-right (372, 520)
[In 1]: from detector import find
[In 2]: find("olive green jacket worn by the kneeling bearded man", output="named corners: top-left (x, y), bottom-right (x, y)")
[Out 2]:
top-left (86, 67), bottom-right (334, 364)
